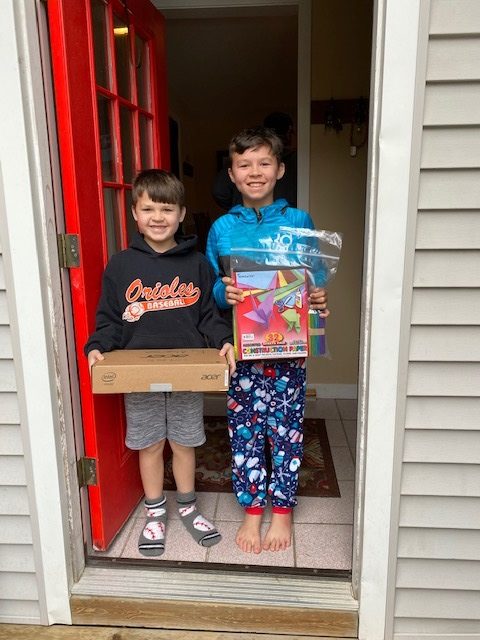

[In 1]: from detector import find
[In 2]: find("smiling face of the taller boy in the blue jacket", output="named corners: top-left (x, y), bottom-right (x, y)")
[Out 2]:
top-left (229, 145), bottom-right (285, 208)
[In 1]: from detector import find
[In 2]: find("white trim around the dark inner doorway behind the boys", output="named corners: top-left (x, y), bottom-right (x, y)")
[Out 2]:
top-left (152, 0), bottom-right (312, 211)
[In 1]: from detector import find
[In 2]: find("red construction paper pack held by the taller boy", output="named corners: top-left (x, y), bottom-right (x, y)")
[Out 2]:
top-left (233, 268), bottom-right (308, 360)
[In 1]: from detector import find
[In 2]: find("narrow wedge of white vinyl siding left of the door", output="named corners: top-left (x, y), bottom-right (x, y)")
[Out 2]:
top-left (0, 248), bottom-right (40, 624)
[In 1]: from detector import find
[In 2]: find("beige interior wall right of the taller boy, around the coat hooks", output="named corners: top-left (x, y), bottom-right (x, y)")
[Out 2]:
top-left (308, 0), bottom-right (373, 385)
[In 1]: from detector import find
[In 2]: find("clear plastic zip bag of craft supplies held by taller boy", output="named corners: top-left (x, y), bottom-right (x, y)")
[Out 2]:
top-left (230, 225), bottom-right (342, 359)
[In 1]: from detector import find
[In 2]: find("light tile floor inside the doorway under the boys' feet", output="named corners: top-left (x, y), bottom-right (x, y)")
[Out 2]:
top-left (91, 398), bottom-right (356, 571)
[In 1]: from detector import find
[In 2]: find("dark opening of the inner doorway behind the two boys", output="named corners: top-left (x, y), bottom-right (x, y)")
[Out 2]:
top-left (166, 13), bottom-right (297, 230)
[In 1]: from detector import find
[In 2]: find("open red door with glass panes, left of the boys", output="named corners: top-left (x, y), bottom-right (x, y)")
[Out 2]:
top-left (47, 0), bottom-right (169, 549)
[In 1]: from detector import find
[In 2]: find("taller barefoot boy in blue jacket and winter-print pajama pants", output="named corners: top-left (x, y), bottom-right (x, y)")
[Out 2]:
top-left (206, 127), bottom-right (329, 553)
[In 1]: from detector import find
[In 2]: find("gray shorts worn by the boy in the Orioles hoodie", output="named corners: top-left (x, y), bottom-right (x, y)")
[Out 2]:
top-left (124, 391), bottom-right (206, 449)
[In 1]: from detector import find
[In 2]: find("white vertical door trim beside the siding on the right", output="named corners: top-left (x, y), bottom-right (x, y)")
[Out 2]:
top-left (353, 0), bottom-right (424, 640)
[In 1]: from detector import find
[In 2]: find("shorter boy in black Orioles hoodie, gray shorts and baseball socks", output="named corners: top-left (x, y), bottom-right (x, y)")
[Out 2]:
top-left (85, 169), bottom-right (235, 556)
